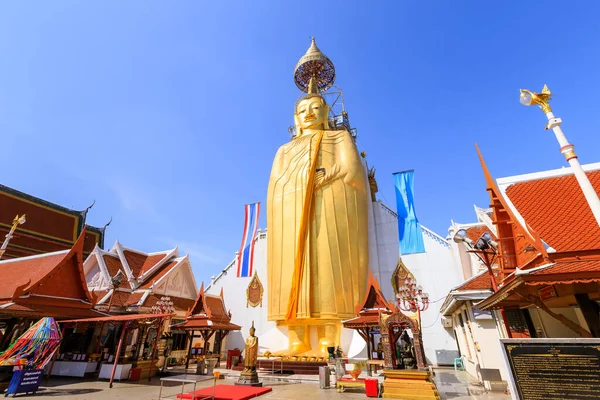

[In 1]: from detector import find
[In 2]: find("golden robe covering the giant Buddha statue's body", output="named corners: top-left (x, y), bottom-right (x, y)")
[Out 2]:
top-left (267, 131), bottom-right (368, 323)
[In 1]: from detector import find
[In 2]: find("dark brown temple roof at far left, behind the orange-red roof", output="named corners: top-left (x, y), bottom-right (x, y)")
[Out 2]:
top-left (0, 185), bottom-right (106, 260)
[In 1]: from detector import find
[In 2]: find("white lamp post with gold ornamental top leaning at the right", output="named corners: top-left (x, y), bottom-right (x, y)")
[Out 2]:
top-left (520, 85), bottom-right (600, 226)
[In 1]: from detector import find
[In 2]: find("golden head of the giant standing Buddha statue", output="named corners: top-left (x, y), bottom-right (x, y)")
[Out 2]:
top-left (294, 79), bottom-right (329, 136)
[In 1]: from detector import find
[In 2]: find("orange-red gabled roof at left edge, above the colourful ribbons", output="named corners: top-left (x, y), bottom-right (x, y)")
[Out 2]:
top-left (0, 229), bottom-right (103, 320)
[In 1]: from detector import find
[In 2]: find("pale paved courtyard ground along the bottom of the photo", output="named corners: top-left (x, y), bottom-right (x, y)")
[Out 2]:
top-left (18, 370), bottom-right (510, 400)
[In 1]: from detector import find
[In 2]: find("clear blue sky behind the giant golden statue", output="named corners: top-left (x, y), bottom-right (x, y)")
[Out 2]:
top-left (0, 0), bottom-right (600, 281)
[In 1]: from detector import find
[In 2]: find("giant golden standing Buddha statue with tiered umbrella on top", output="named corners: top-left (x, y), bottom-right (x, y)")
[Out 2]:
top-left (267, 38), bottom-right (369, 355)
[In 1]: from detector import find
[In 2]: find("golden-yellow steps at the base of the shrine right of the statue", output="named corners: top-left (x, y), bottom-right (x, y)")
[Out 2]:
top-left (381, 369), bottom-right (440, 400)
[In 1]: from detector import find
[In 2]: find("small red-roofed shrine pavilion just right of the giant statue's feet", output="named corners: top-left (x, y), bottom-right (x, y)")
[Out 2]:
top-left (342, 271), bottom-right (397, 358)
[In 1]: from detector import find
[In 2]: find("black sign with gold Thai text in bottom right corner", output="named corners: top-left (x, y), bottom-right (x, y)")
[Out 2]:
top-left (502, 339), bottom-right (600, 400)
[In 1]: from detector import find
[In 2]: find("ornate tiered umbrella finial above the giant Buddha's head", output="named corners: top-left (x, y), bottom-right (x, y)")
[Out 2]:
top-left (294, 38), bottom-right (335, 93)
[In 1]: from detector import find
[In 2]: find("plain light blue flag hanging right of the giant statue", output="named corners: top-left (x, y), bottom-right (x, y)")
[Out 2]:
top-left (394, 170), bottom-right (425, 254)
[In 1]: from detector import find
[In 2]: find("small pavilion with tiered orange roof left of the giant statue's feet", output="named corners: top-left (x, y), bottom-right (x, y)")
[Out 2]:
top-left (172, 283), bottom-right (242, 368)
